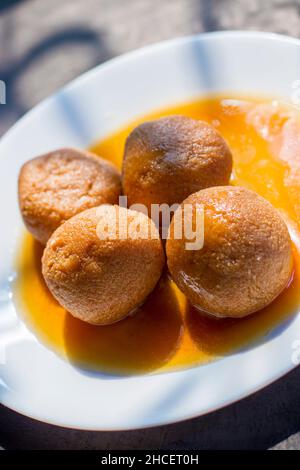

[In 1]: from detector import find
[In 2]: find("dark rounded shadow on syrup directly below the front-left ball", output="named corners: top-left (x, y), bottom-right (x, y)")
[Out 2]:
top-left (64, 276), bottom-right (182, 374)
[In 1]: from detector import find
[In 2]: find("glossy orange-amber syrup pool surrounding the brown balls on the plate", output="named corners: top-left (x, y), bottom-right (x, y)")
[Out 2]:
top-left (14, 96), bottom-right (300, 375)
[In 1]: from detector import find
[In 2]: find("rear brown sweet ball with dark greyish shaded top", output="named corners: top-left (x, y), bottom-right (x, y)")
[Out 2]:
top-left (122, 116), bottom-right (232, 210)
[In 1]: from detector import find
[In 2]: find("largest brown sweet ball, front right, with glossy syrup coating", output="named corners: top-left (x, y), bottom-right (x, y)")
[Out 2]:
top-left (167, 186), bottom-right (293, 318)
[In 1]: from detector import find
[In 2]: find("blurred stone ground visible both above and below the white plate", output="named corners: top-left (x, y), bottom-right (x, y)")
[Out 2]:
top-left (0, 0), bottom-right (300, 450)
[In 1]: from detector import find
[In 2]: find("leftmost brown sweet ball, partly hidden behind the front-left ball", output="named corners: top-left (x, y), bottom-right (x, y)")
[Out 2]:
top-left (19, 148), bottom-right (121, 244)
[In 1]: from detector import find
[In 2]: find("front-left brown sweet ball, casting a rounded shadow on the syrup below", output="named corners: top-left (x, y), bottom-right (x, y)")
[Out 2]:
top-left (42, 205), bottom-right (164, 325)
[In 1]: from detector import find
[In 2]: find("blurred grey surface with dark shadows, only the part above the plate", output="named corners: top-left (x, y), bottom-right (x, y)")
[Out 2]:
top-left (0, 0), bottom-right (300, 136)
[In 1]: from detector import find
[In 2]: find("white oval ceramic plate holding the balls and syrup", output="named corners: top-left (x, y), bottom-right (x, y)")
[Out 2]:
top-left (0, 32), bottom-right (300, 430)
